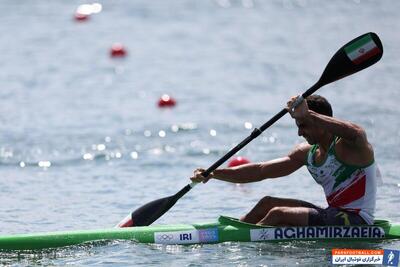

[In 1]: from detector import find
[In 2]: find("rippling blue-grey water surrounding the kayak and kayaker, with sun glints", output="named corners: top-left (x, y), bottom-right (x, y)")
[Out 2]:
top-left (0, 0), bottom-right (400, 266)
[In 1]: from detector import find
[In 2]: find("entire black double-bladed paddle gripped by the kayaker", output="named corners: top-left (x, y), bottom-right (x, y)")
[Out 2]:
top-left (126, 32), bottom-right (383, 226)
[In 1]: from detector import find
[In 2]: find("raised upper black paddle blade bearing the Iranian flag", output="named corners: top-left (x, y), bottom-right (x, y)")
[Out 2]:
top-left (318, 32), bottom-right (383, 86)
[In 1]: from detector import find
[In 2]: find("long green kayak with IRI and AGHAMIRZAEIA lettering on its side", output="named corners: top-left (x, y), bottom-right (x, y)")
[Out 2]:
top-left (0, 216), bottom-right (400, 250)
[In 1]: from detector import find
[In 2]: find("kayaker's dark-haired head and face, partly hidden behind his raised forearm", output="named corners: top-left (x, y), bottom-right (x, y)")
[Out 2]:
top-left (296, 95), bottom-right (333, 145)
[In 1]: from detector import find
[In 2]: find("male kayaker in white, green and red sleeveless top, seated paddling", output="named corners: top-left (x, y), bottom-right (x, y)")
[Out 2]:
top-left (191, 95), bottom-right (377, 226)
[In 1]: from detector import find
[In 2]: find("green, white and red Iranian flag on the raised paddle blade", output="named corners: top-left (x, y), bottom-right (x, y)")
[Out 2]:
top-left (344, 34), bottom-right (381, 64)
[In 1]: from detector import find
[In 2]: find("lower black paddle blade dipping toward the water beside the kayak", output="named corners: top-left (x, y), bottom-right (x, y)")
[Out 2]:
top-left (117, 184), bottom-right (192, 227)
